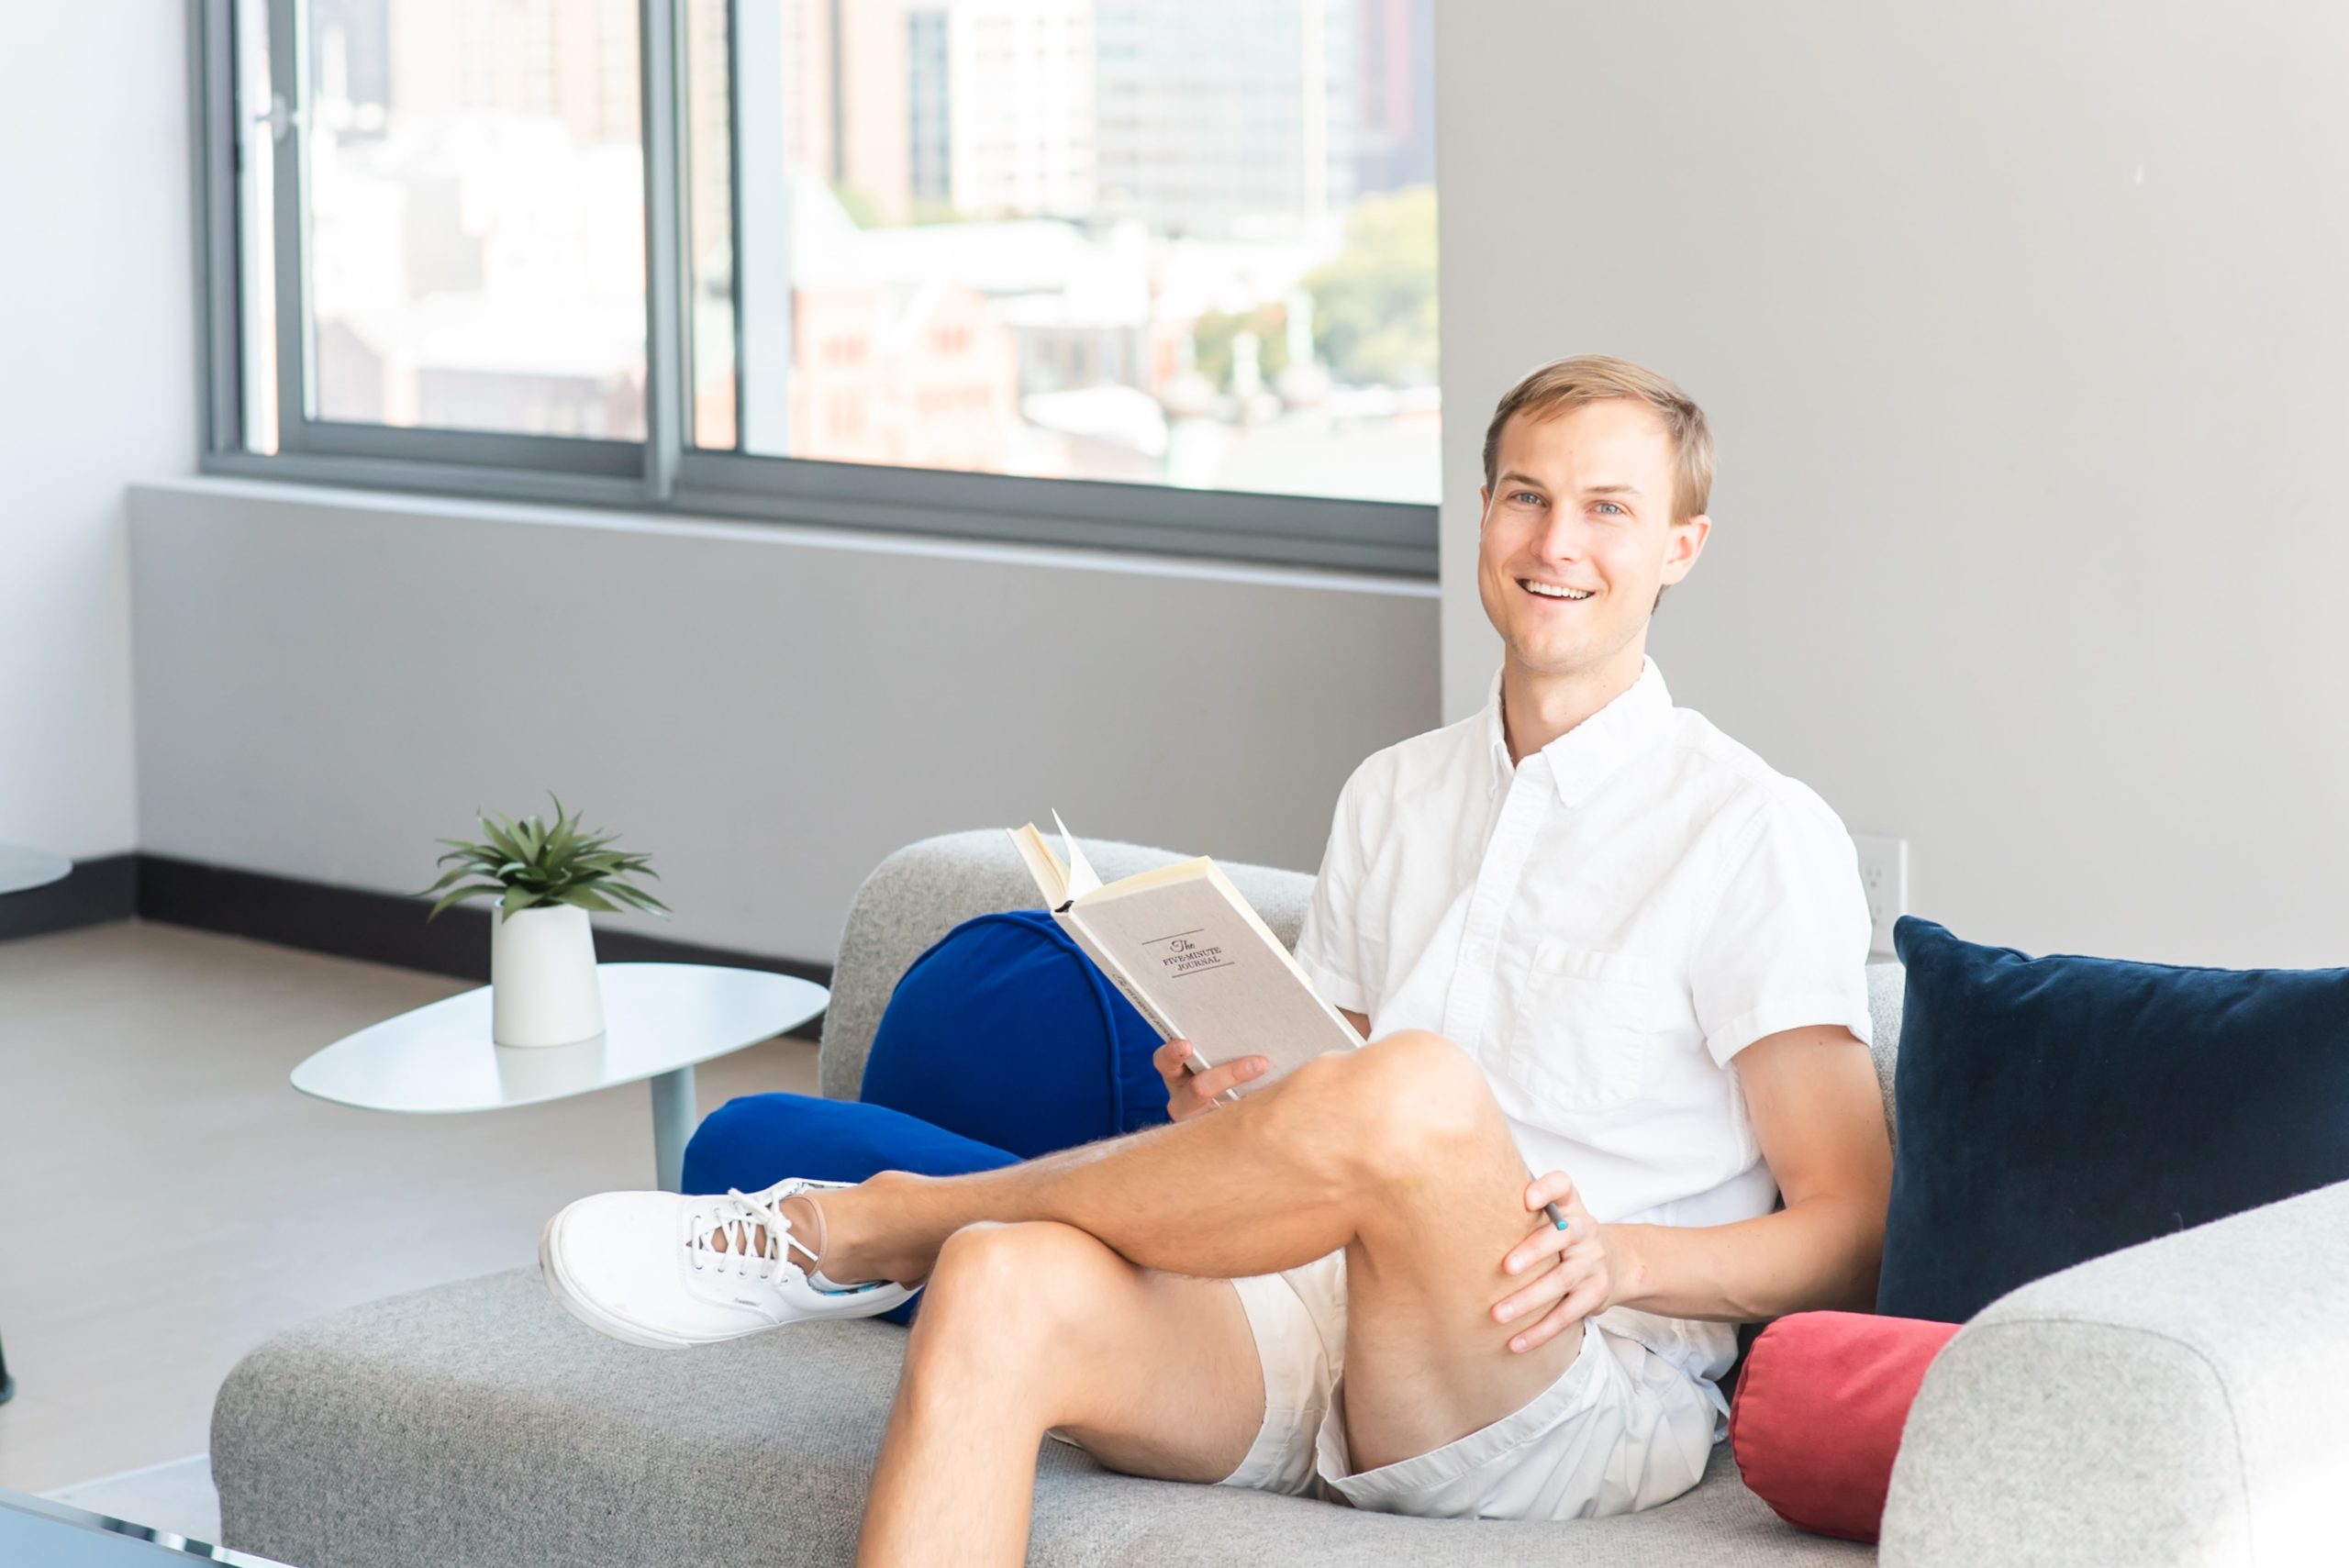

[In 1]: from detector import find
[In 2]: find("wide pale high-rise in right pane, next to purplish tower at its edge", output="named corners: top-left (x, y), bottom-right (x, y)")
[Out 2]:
top-left (1092, 0), bottom-right (1360, 237)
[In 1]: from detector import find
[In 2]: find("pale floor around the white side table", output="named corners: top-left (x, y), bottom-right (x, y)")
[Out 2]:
top-left (0, 920), bottom-right (815, 1502)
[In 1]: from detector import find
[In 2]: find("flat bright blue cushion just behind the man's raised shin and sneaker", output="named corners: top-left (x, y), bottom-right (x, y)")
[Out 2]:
top-left (684, 1094), bottom-right (1017, 1324)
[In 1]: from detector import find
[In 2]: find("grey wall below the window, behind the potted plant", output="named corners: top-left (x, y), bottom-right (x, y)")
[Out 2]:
top-left (131, 479), bottom-right (1438, 960)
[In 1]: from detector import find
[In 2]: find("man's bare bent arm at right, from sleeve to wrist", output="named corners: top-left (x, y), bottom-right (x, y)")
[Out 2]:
top-left (1599, 1026), bottom-right (1893, 1324)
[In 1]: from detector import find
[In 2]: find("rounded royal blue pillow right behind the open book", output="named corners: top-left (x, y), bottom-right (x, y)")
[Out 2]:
top-left (857, 908), bottom-right (1167, 1160)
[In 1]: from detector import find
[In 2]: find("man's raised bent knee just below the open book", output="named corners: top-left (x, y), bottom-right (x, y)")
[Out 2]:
top-left (1295, 1030), bottom-right (1492, 1181)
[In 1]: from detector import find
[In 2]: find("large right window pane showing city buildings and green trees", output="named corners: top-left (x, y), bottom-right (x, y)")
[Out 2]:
top-left (691, 0), bottom-right (1438, 502)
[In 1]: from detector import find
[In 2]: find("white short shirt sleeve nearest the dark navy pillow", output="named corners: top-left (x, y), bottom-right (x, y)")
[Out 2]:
top-left (1689, 789), bottom-right (1870, 1068)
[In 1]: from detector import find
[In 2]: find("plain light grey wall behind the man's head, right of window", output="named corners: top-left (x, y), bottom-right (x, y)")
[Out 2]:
top-left (1438, 0), bottom-right (2349, 964)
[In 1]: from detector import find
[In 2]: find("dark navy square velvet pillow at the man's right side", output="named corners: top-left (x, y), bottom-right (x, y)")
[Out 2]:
top-left (1876, 916), bottom-right (2349, 1324)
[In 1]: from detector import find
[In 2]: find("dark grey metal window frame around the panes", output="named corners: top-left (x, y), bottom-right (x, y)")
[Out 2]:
top-left (188, 0), bottom-right (1438, 580)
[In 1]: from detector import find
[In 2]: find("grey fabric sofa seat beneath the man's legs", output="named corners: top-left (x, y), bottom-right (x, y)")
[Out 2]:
top-left (211, 1268), bottom-right (1875, 1568)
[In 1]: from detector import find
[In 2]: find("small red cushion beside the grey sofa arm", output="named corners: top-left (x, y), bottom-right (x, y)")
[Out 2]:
top-left (1729, 1312), bottom-right (1959, 1540)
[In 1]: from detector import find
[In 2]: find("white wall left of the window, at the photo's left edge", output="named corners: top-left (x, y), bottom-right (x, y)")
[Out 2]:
top-left (0, 0), bottom-right (195, 857)
